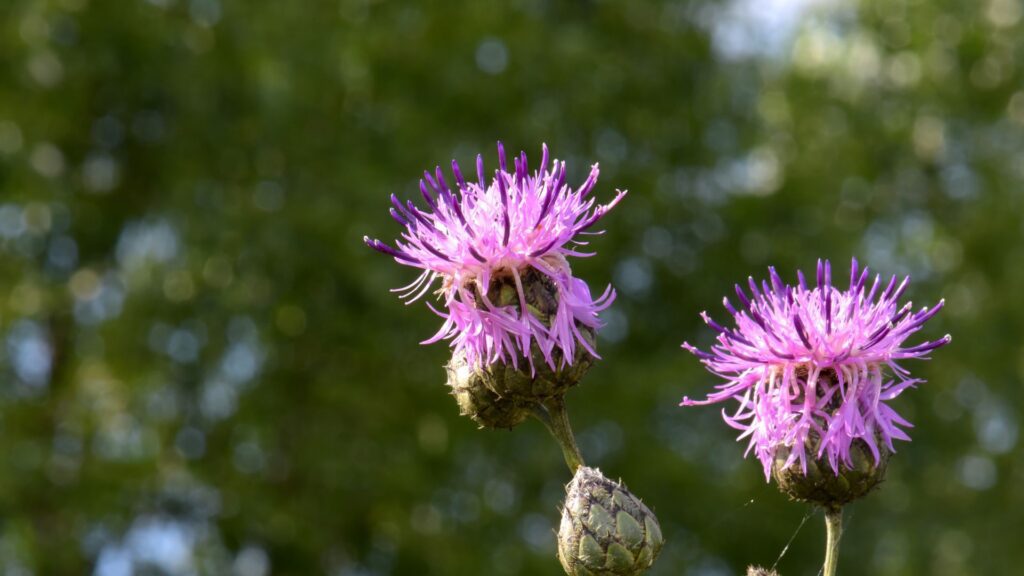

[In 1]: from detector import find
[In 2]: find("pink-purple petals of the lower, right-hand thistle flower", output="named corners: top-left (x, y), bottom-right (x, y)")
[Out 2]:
top-left (681, 258), bottom-right (950, 478)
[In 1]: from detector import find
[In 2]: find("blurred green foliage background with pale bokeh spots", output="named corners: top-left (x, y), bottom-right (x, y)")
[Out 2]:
top-left (0, 0), bottom-right (1024, 576)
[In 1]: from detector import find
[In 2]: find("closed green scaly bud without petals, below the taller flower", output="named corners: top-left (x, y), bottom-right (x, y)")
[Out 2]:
top-left (558, 466), bottom-right (665, 576)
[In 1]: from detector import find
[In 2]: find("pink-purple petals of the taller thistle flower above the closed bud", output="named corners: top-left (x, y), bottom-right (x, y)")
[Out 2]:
top-left (364, 142), bottom-right (626, 369)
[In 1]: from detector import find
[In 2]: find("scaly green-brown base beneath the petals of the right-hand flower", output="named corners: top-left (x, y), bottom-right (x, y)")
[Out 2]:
top-left (772, 434), bottom-right (891, 508)
